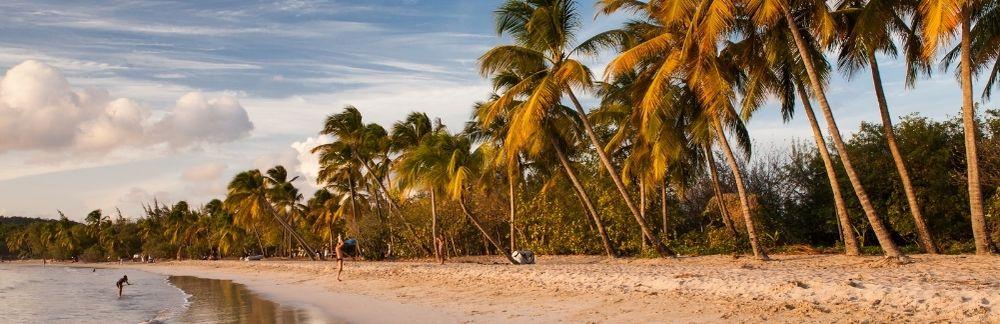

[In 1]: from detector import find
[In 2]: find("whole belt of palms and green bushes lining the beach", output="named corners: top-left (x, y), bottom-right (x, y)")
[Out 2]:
top-left (0, 0), bottom-right (1000, 260)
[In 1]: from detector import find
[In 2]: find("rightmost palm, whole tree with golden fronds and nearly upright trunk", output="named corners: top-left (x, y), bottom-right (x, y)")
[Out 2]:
top-left (920, 0), bottom-right (998, 255)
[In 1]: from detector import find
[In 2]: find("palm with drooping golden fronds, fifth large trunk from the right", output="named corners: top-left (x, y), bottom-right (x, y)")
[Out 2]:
top-left (588, 0), bottom-right (768, 260)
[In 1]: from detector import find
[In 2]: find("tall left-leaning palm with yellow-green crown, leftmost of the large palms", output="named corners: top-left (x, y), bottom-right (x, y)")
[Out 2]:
top-left (479, 0), bottom-right (672, 257)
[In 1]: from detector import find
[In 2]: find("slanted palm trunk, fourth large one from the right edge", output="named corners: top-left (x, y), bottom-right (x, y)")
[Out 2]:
top-left (795, 83), bottom-right (861, 256)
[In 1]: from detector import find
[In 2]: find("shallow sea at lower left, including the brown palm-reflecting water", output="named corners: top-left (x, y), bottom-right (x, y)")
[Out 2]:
top-left (0, 263), bottom-right (337, 324)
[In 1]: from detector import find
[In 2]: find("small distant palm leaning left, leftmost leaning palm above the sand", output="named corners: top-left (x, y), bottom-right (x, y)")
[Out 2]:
top-left (224, 170), bottom-right (316, 260)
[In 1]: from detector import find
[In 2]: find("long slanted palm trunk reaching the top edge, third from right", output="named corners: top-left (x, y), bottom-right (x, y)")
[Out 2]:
top-left (781, 3), bottom-right (909, 261)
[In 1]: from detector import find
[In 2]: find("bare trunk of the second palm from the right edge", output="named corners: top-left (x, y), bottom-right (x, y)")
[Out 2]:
top-left (868, 53), bottom-right (938, 254)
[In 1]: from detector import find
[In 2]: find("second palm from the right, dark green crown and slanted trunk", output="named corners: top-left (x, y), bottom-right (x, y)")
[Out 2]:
top-left (835, 0), bottom-right (938, 254)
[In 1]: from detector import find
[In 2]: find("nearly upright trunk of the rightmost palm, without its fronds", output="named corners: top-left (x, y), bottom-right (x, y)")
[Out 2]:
top-left (960, 19), bottom-right (993, 255)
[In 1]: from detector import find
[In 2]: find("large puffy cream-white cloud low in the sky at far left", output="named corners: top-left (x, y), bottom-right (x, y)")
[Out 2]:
top-left (0, 60), bottom-right (253, 156)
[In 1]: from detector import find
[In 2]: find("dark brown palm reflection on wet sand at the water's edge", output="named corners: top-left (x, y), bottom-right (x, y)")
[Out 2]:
top-left (169, 276), bottom-right (335, 324)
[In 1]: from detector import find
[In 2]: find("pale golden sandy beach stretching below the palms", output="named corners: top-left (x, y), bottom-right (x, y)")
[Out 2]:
top-left (84, 255), bottom-right (1000, 323)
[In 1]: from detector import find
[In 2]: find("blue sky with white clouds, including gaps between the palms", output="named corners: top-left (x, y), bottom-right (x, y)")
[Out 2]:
top-left (0, 0), bottom-right (981, 220)
